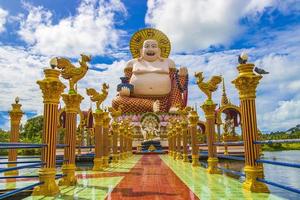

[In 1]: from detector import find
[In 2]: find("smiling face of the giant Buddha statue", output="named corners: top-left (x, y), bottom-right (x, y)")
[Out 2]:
top-left (142, 40), bottom-right (160, 62)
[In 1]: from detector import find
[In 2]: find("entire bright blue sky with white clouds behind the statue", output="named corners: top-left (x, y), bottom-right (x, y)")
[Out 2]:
top-left (0, 0), bottom-right (300, 131)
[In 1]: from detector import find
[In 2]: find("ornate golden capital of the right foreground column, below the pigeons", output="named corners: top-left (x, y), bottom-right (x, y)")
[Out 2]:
top-left (232, 63), bottom-right (262, 99)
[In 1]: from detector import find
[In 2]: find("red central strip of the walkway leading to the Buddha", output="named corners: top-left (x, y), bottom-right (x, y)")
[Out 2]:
top-left (106, 155), bottom-right (199, 200)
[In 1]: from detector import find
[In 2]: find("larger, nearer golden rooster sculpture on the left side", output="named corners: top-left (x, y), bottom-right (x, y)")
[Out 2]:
top-left (50, 54), bottom-right (91, 92)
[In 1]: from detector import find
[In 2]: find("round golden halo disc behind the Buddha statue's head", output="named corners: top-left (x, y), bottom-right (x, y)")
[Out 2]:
top-left (130, 28), bottom-right (171, 58)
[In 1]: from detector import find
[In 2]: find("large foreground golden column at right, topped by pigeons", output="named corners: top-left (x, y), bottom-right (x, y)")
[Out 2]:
top-left (232, 57), bottom-right (269, 193)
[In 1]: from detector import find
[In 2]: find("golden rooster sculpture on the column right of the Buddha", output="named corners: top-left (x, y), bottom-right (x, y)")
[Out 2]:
top-left (195, 72), bottom-right (222, 100)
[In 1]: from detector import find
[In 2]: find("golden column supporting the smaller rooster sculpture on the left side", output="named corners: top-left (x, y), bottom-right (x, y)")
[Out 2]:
top-left (93, 109), bottom-right (104, 171)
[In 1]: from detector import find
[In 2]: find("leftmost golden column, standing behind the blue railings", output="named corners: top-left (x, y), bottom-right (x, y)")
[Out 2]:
top-left (4, 97), bottom-right (24, 176)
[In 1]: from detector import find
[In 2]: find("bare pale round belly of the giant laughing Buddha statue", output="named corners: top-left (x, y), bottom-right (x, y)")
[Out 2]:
top-left (130, 73), bottom-right (171, 96)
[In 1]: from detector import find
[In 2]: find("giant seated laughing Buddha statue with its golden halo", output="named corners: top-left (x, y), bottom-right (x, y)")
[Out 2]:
top-left (112, 28), bottom-right (188, 113)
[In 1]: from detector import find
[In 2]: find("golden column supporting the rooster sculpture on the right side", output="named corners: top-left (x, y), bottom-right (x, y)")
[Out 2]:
top-left (201, 100), bottom-right (220, 174)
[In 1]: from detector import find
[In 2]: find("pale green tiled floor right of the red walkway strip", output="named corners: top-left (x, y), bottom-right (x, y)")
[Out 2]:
top-left (160, 155), bottom-right (281, 200)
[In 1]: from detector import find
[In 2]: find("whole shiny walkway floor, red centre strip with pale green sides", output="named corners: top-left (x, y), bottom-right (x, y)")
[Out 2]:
top-left (0, 155), bottom-right (286, 200)
